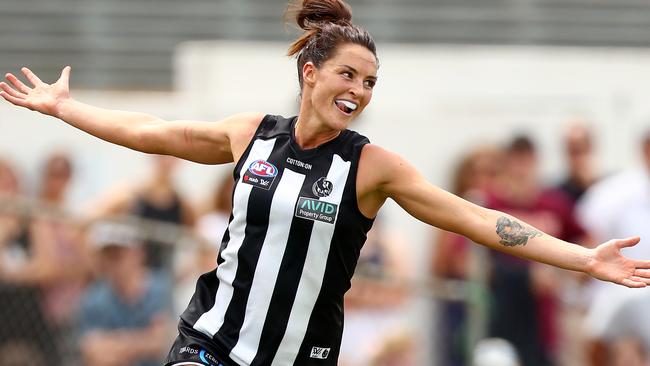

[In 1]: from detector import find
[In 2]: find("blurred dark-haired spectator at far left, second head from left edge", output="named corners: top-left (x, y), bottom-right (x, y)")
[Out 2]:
top-left (1, 153), bottom-right (89, 364)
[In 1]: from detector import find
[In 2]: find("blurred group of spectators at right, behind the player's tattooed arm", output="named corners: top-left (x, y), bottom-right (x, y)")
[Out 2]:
top-left (431, 121), bottom-right (650, 366)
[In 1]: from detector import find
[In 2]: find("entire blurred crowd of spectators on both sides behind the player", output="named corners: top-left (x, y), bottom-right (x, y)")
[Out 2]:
top-left (0, 121), bottom-right (650, 366)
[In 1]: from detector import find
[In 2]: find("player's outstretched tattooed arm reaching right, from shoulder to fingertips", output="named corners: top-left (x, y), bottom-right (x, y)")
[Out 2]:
top-left (359, 145), bottom-right (650, 287)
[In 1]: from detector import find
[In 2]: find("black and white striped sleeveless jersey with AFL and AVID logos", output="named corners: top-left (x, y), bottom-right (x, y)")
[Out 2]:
top-left (181, 115), bottom-right (373, 366)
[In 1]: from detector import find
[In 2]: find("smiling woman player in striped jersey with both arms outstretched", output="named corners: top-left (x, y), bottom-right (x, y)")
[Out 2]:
top-left (0, 0), bottom-right (650, 366)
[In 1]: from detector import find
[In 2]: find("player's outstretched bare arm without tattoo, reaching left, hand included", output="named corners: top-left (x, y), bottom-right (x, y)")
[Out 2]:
top-left (0, 66), bottom-right (263, 164)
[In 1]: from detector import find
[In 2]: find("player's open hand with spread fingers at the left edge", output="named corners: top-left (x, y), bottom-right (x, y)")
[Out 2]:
top-left (0, 66), bottom-right (70, 116)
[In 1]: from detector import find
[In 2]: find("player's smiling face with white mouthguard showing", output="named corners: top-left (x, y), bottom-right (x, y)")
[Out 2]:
top-left (301, 43), bottom-right (377, 130)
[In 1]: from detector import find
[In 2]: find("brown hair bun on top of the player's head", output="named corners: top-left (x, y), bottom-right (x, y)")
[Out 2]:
top-left (294, 0), bottom-right (352, 31)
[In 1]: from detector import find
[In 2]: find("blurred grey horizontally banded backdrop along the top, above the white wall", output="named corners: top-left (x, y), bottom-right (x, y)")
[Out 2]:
top-left (0, 0), bottom-right (650, 90)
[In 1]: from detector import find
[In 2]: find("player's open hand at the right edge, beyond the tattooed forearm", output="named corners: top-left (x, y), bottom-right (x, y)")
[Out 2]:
top-left (589, 237), bottom-right (650, 288)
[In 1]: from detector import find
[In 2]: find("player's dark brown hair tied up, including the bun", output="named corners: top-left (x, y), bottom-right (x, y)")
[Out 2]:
top-left (285, 0), bottom-right (377, 89)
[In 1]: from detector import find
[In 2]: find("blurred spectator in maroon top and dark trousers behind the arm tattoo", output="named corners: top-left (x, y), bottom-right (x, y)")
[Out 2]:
top-left (488, 136), bottom-right (585, 366)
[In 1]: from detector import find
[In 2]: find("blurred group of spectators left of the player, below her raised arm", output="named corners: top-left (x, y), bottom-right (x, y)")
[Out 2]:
top-left (0, 152), bottom-right (225, 366)
